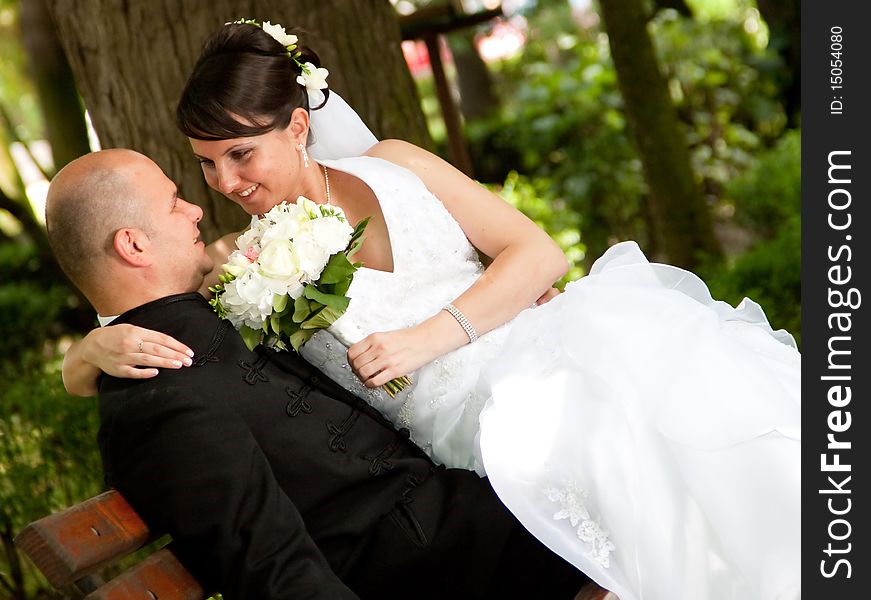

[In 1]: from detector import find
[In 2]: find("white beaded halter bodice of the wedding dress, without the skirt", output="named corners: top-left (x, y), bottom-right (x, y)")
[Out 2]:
top-left (302, 156), bottom-right (507, 471)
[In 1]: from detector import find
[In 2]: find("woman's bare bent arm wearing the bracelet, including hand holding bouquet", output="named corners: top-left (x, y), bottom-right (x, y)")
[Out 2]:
top-left (349, 140), bottom-right (568, 387)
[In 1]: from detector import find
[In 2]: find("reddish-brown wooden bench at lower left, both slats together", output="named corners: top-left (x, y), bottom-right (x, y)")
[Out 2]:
top-left (15, 490), bottom-right (206, 600)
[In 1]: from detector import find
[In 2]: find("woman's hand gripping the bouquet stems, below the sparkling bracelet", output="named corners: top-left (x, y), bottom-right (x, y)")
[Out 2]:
top-left (348, 327), bottom-right (435, 388)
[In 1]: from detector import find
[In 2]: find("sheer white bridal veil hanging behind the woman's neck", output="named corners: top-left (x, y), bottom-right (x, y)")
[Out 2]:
top-left (308, 90), bottom-right (378, 160)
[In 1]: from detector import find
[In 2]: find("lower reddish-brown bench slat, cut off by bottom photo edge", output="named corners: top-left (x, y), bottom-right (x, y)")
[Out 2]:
top-left (85, 548), bottom-right (205, 600)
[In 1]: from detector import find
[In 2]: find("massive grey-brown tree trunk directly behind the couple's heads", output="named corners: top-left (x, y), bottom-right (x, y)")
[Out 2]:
top-left (47, 0), bottom-right (429, 239)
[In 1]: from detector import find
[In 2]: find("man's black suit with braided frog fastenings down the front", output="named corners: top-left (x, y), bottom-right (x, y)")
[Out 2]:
top-left (99, 294), bottom-right (515, 599)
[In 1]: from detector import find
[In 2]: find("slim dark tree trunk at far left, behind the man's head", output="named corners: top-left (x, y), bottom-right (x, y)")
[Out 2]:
top-left (21, 0), bottom-right (91, 170)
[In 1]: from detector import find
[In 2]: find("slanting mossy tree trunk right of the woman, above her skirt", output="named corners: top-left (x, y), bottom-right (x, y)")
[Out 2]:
top-left (599, 0), bottom-right (720, 268)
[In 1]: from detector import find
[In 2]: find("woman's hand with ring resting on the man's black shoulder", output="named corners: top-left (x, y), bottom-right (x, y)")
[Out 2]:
top-left (81, 323), bottom-right (194, 379)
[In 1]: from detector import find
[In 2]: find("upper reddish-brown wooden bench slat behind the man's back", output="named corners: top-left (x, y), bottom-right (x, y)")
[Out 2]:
top-left (15, 490), bottom-right (150, 588)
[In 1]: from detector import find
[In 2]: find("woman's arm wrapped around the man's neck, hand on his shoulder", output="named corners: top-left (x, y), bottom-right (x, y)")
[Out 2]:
top-left (62, 232), bottom-right (239, 396)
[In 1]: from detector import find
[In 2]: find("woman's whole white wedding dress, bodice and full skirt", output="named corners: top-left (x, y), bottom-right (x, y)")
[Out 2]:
top-left (302, 157), bottom-right (801, 600)
